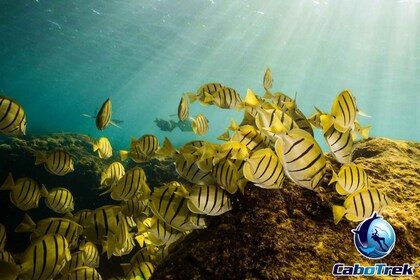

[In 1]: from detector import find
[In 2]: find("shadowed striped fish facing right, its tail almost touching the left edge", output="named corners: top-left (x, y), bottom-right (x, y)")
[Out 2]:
top-left (0, 173), bottom-right (41, 211)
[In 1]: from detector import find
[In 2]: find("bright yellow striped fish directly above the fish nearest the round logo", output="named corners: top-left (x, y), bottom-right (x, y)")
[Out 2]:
top-left (330, 163), bottom-right (369, 195)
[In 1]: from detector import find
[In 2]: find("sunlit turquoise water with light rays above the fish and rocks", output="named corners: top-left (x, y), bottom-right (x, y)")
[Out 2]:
top-left (0, 0), bottom-right (420, 149)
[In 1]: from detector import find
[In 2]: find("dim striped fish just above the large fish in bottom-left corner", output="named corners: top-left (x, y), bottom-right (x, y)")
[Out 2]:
top-left (15, 213), bottom-right (83, 248)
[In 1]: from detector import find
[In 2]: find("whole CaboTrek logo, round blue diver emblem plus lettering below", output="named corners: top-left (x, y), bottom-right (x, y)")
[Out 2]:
top-left (332, 212), bottom-right (415, 276)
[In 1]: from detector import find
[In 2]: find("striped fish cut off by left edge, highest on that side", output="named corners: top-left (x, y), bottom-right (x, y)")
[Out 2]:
top-left (0, 96), bottom-right (26, 135)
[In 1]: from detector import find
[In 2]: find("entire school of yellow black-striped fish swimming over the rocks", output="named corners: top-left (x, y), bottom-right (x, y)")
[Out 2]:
top-left (0, 68), bottom-right (390, 279)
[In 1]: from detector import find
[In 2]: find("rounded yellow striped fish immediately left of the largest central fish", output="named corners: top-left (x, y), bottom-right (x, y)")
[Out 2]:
top-left (243, 148), bottom-right (284, 189)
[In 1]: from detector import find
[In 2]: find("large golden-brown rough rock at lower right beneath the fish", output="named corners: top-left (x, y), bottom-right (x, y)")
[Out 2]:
top-left (152, 138), bottom-right (420, 279)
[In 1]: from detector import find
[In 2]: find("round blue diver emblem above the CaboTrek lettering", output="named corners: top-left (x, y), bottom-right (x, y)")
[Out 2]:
top-left (352, 212), bottom-right (395, 259)
